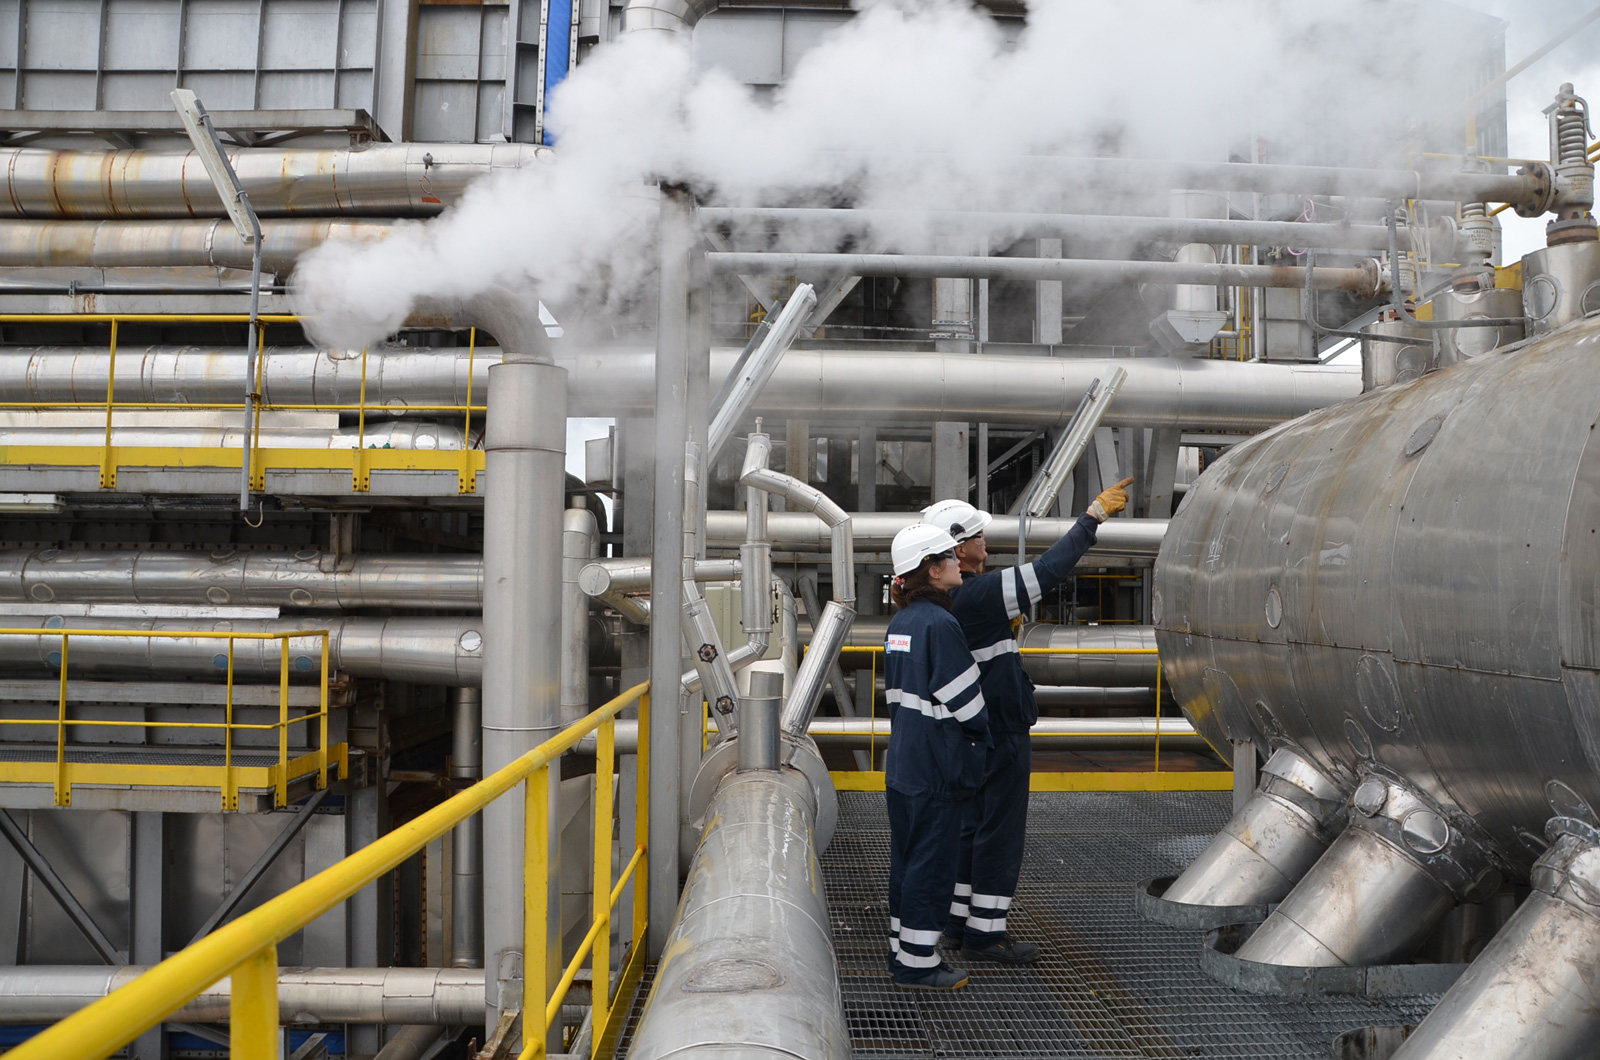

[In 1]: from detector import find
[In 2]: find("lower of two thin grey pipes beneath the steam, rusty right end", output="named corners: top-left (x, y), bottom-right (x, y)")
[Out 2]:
top-left (706, 253), bottom-right (1379, 298)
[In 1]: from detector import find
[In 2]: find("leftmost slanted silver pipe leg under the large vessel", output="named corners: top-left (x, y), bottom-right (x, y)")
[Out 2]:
top-left (1162, 748), bottom-right (1346, 906)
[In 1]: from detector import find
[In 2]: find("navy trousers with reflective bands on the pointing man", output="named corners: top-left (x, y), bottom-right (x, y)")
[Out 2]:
top-left (963, 732), bottom-right (1034, 948)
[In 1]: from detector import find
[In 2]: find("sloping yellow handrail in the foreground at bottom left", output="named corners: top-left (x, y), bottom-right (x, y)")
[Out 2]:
top-left (6, 684), bottom-right (648, 1060)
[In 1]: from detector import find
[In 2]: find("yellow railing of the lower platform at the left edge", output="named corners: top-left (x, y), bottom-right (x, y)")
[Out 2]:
top-left (0, 626), bottom-right (336, 812)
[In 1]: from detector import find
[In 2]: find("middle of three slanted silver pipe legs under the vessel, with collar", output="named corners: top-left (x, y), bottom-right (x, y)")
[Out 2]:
top-left (1237, 775), bottom-right (1501, 967)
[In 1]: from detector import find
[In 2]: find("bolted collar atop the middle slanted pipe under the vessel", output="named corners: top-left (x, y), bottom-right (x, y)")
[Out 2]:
top-left (1350, 773), bottom-right (1501, 901)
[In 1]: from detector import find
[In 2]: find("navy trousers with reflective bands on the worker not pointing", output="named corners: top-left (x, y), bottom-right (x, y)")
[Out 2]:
top-left (885, 788), bottom-right (962, 982)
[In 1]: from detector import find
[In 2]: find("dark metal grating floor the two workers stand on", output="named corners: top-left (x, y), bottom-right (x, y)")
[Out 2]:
top-left (822, 793), bottom-right (1437, 1060)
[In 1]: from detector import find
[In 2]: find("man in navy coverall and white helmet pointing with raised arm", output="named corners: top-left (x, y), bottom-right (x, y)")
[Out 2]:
top-left (923, 479), bottom-right (1133, 964)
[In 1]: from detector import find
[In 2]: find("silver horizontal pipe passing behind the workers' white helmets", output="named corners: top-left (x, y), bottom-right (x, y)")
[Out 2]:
top-left (706, 511), bottom-right (1166, 557)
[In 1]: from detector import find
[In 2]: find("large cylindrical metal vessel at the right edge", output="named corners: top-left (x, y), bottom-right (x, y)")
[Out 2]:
top-left (1152, 322), bottom-right (1600, 874)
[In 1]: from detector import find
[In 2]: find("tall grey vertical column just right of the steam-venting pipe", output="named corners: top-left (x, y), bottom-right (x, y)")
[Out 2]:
top-left (646, 184), bottom-right (694, 959)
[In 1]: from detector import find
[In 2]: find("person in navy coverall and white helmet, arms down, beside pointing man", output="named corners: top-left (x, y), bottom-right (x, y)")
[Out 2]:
top-left (883, 524), bottom-right (989, 990)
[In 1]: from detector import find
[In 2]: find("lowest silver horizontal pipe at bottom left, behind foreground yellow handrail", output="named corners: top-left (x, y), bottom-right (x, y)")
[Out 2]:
top-left (0, 964), bottom-right (483, 1026)
